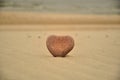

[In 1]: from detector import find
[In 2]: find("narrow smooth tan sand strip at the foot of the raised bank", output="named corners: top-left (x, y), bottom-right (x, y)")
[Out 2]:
top-left (0, 24), bottom-right (120, 31)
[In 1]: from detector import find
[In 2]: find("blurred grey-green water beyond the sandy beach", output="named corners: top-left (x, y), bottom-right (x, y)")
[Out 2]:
top-left (0, 0), bottom-right (120, 15)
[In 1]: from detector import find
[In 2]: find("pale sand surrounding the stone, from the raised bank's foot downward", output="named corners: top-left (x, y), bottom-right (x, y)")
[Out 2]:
top-left (0, 11), bottom-right (120, 80)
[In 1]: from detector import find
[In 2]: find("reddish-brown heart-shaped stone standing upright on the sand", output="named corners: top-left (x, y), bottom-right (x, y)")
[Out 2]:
top-left (46, 35), bottom-right (74, 57)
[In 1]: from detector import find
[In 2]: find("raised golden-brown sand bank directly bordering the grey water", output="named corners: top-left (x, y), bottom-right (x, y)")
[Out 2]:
top-left (0, 11), bottom-right (120, 25)
